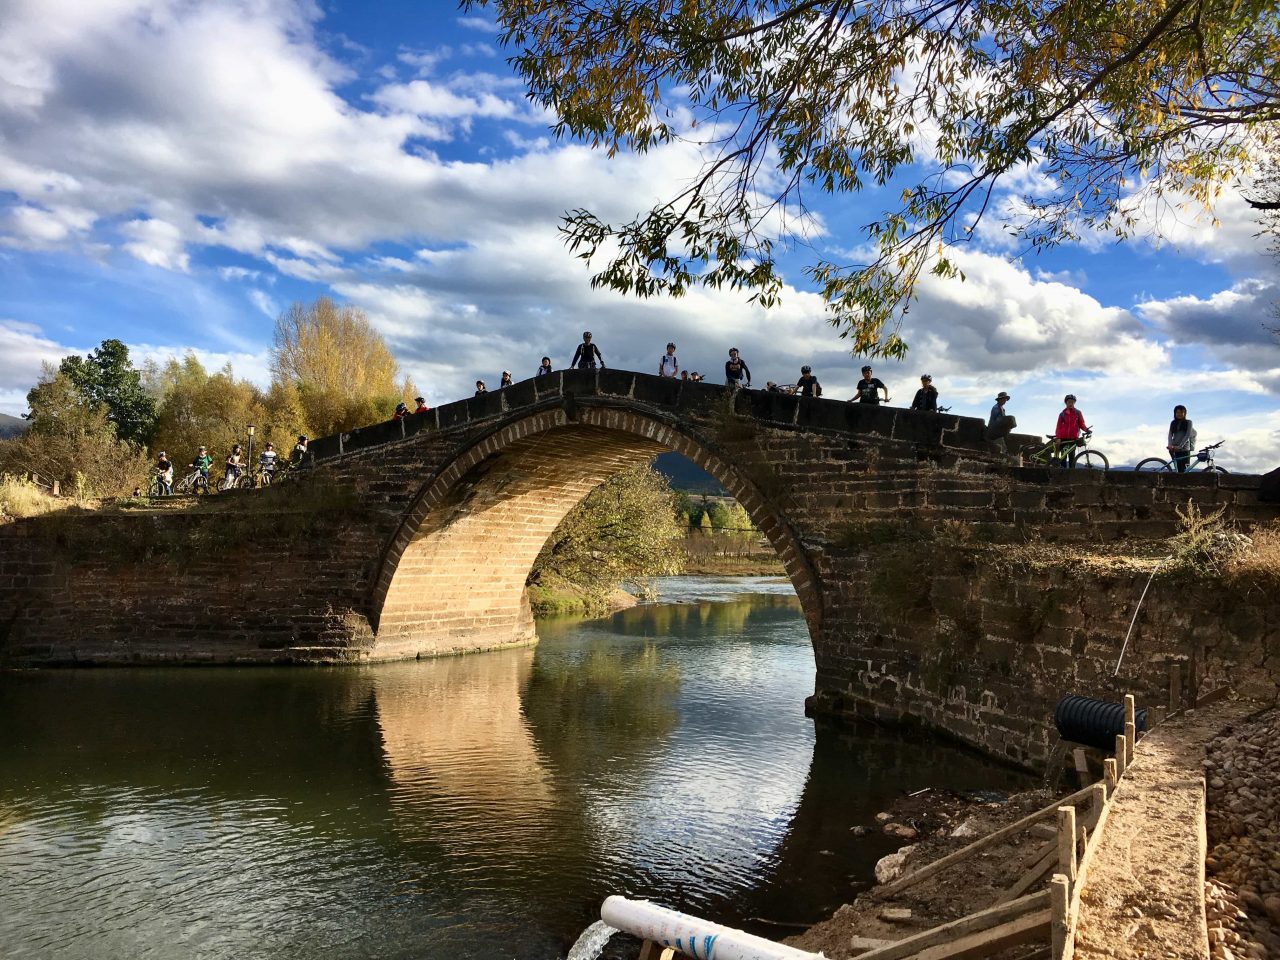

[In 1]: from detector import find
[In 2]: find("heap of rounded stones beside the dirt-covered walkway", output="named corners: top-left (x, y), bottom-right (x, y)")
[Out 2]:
top-left (1204, 710), bottom-right (1280, 960)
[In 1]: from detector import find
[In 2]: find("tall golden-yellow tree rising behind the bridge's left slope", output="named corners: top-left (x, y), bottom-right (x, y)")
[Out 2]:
top-left (271, 297), bottom-right (415, 436)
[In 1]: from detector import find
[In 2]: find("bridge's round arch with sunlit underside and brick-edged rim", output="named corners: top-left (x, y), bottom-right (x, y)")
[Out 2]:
top-left (367, 406), bottom-right (822, 659)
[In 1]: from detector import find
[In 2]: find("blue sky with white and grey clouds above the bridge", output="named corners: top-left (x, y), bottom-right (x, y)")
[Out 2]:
top-left (0, 0), bottom-right (1280, 470)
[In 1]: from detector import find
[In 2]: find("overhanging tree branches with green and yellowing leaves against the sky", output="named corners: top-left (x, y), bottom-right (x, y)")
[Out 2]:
top-left (465, 0), bottom-right (1280, 356)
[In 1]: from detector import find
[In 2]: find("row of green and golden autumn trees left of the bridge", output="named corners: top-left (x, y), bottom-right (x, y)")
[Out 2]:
top-left (0, 297), bottom-right (416, 497)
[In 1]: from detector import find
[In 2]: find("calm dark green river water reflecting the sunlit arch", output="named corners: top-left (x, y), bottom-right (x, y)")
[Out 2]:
top-left (0, 579), bottom-right (1024, 960)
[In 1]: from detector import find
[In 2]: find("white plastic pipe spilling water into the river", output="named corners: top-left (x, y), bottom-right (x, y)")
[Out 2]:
top-left (600, 896), bottom-right (822, 960)
